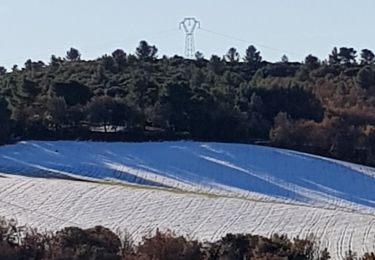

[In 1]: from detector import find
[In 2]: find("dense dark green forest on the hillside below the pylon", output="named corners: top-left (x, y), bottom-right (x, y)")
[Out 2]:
top-left (0, 41), bottom-right (375, 165)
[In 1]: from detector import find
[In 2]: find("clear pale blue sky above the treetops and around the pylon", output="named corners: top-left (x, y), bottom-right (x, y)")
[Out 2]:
top-left (0, 0), bottom-right (375, 68)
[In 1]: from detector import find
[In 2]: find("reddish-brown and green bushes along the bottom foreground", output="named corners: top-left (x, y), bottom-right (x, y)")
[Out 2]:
top-left (0, 215), bottom-right (368, 260)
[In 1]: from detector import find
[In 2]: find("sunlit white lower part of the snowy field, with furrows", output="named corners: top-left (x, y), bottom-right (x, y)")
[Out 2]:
top-left (0, 177), bottom-right (375, 259)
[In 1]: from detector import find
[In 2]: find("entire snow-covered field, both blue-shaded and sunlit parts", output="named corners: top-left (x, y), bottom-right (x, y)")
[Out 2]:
top-left (0, 141), bottom-right (375, 259)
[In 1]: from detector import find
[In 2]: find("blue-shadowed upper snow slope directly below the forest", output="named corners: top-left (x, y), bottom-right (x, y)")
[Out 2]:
top-left (0, 141), bottom-right (375, 209)
